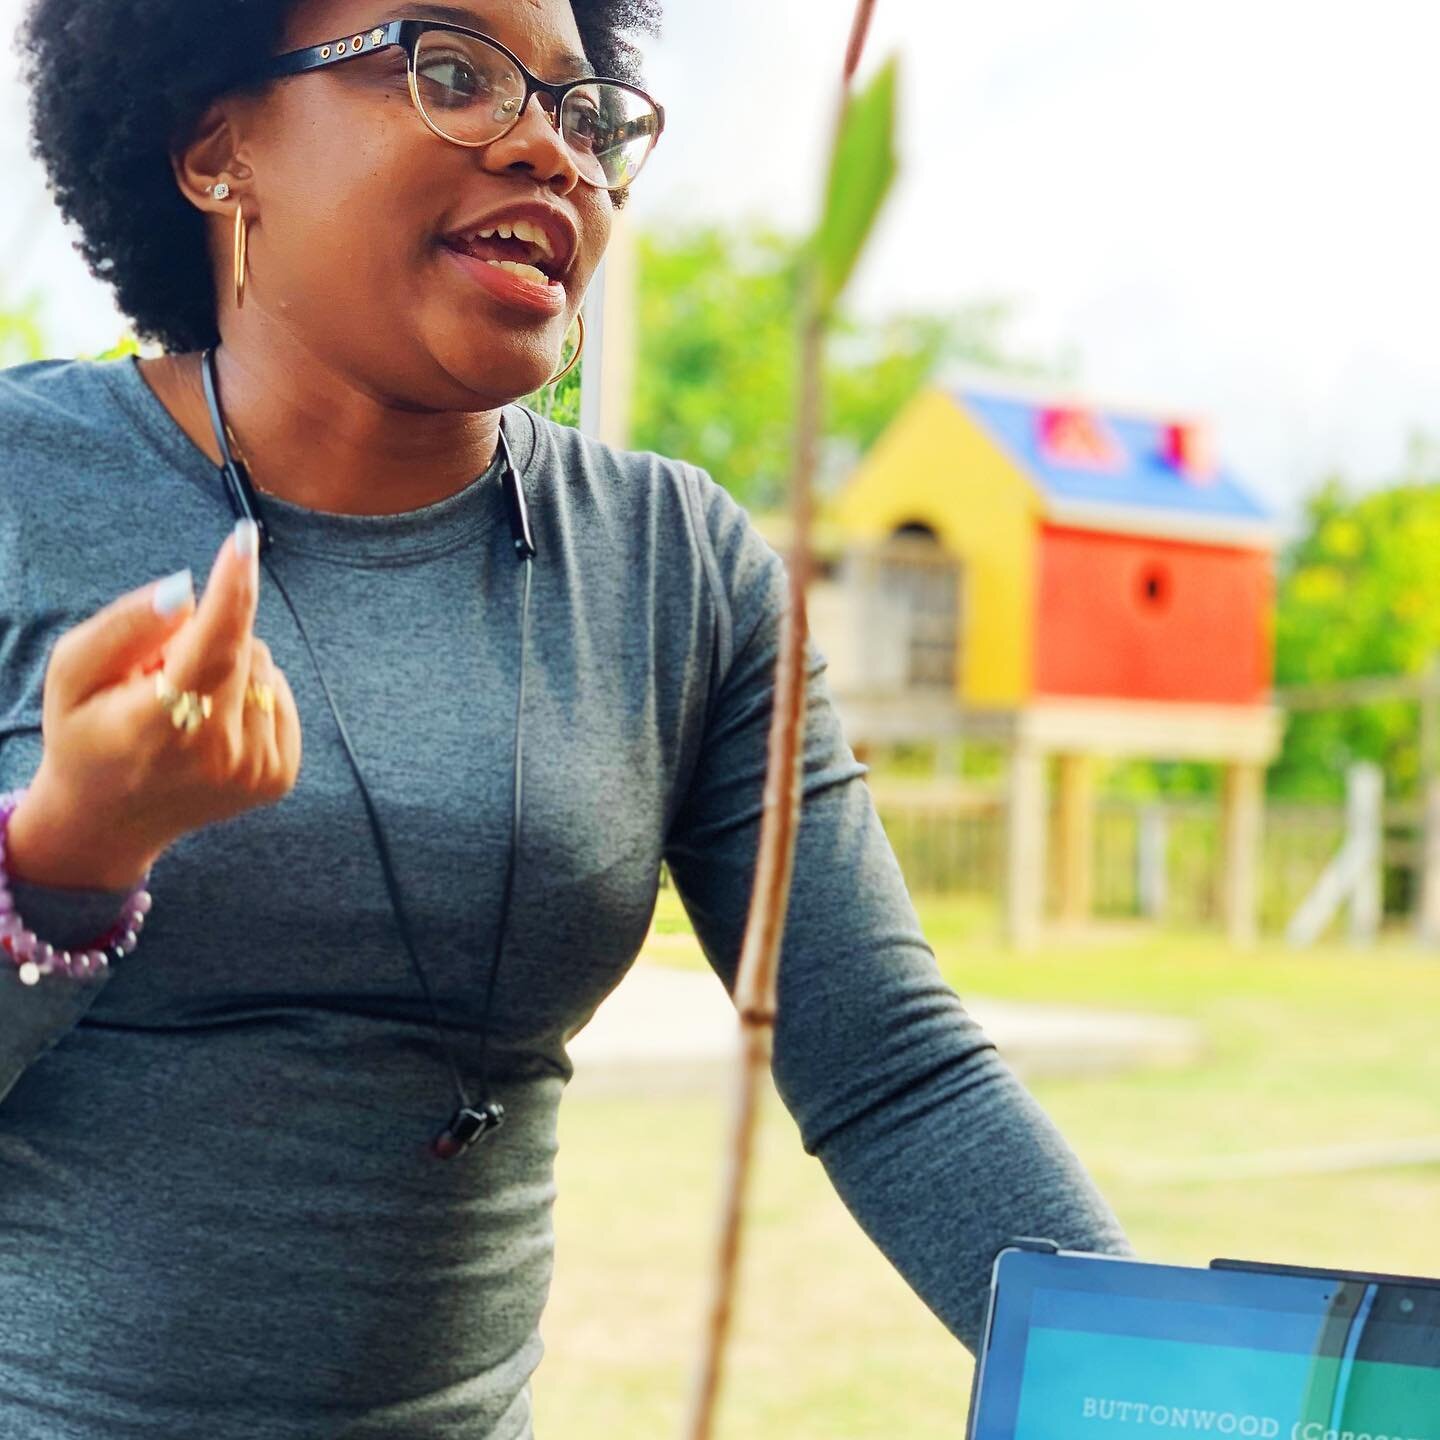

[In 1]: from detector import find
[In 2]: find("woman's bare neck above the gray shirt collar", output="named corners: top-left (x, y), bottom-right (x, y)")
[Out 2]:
top-left (140, 346), bottom-right (500, 516)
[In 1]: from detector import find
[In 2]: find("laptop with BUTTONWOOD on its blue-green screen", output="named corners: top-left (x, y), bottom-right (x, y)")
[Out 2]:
top-left (968, 1241), bottom-right (1440, 1440)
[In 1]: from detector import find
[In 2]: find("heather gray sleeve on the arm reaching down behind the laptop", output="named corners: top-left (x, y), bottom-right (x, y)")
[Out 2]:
top-left (667, 478), bottom-right (1128, 1349)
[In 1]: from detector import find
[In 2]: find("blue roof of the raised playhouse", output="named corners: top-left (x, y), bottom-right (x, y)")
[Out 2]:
top-left (952, 387), bottom-right (1274, 524)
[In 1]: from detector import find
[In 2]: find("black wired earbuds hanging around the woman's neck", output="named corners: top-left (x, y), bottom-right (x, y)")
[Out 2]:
top-left (200, 348), bottom-right (537, 1159)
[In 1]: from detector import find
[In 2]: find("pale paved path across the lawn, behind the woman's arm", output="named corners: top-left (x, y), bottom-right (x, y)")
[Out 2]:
top-left (570, 959), bottom-right (1201, 1092)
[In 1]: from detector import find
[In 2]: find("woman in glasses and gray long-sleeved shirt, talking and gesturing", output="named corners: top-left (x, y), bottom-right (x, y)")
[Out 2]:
top-left (0, 0), bottom-right (1125, 1440)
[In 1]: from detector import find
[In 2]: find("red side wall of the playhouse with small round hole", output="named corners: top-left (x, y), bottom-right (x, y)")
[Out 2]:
top-left (1035, 524), bottom-right (1272, 704)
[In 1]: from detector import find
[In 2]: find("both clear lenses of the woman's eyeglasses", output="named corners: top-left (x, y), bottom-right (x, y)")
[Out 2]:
top-left (415, 30), bottom-right (660, 190)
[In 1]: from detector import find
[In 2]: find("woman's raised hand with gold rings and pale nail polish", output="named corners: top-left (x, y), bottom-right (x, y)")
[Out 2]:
top-left (7, 521), bottom-right (301, 890)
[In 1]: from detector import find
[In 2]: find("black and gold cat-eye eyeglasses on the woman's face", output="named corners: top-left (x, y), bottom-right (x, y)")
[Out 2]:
top-left (264, 20), bottom-right (665, 190)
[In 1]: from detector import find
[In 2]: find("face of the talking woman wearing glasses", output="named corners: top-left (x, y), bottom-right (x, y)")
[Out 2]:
top-left (220, 0), bottom-right (612, 410)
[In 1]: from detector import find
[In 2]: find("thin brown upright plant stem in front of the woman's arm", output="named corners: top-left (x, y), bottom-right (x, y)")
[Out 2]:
top-left (684, 0), bottom-right (874, 1440)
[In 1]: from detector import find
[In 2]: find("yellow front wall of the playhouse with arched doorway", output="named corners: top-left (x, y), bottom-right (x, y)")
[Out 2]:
top-left (832, 390), bottom-right (1040, 707)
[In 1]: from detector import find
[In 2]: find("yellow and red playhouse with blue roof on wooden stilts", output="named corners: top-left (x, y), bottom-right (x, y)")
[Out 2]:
top-left (821, 383), bottom-right (1280, 940)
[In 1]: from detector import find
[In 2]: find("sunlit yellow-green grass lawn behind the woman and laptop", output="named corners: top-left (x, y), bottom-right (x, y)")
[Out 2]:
top-left (536, 893), bottom-right (1440, 1440)
